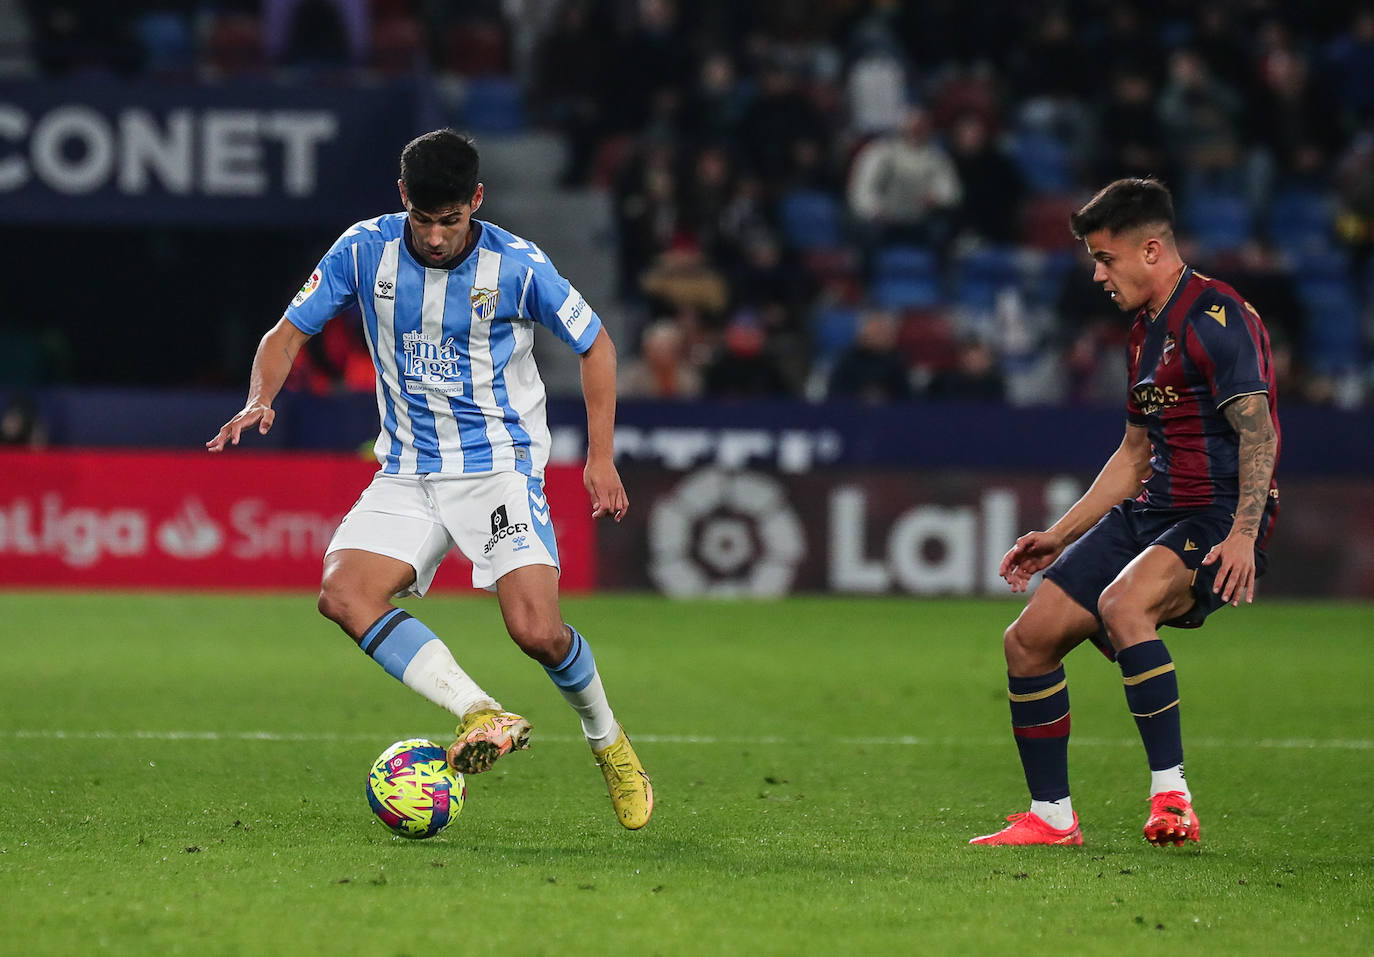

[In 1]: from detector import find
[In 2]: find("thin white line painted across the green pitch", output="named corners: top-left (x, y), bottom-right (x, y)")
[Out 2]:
top-left (0, 730), bottom-right (1374, 751)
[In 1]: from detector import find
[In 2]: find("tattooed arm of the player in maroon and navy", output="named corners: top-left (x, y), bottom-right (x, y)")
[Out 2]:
top-left (1202, 394), bottom-right (1278, 606)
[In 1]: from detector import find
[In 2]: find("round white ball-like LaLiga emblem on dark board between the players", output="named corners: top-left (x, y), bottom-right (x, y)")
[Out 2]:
top-left (649, 468), bottom-right (807, 597)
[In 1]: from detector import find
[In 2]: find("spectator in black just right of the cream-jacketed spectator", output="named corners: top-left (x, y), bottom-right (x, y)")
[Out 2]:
top-left (949, 111), bottom-right (1026, 243)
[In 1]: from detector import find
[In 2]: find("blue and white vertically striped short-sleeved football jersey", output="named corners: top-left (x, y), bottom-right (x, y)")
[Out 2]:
top-left (286, 213), bottom-right (602, 478)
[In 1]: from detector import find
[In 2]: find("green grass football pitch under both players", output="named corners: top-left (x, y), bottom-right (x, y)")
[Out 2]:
top-left (0, 592), bottom-right (1374, 957)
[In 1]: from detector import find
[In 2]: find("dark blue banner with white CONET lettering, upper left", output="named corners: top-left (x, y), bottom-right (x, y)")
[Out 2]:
top-left (0, 80), bottom-right (427, 227)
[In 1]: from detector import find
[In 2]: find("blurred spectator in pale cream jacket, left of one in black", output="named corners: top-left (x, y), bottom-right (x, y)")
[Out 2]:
top-left (848, 108), bottom-right (963, 263)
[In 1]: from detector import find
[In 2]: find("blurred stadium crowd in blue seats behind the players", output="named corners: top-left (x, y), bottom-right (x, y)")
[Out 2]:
top-left (0, 0), bottom-right (1374, 406)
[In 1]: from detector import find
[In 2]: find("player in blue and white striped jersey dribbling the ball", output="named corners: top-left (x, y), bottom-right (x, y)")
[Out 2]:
top-left (206, 129), bottom-right (654, 829)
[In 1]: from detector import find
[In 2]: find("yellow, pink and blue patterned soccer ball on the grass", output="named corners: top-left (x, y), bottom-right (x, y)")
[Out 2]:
top-left (367, 737), bottom-right (467, 839)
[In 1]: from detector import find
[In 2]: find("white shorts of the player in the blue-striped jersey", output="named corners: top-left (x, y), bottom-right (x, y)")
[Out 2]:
top-left (324, 472), bottom-right (558, 595)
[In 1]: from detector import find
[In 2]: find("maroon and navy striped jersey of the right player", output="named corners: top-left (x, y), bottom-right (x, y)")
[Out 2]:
top-left (1127, 268), bottom-right (1279, 532)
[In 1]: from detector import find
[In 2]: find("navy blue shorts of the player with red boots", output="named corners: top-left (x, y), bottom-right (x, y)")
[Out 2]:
top-left (1044, 500), bottom-right (1268, 660)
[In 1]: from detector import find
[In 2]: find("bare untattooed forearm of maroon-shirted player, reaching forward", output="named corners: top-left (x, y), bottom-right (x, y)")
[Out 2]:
top-left (998, 423), bottom-right (1150, 592)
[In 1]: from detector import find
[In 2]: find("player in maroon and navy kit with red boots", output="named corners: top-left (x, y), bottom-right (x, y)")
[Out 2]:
top-left (970, 178), bottom-right (1279, 844)
